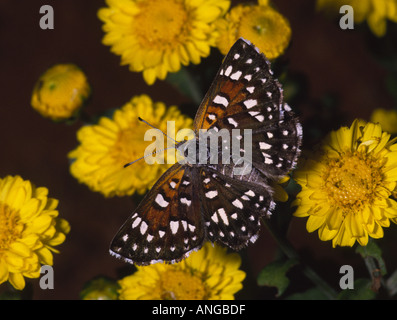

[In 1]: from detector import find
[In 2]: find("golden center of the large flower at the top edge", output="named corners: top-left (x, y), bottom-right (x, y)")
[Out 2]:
top-left (133, 0), bottom-right (189, 50)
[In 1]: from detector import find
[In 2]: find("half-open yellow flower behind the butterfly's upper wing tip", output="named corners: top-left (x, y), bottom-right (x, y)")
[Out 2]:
top-left (216, 0), bottom-right (291, 59)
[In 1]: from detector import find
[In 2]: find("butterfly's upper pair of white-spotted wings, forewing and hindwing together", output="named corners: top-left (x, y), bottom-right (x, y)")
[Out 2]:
top-left (194, 38), bottom-right (302, 179)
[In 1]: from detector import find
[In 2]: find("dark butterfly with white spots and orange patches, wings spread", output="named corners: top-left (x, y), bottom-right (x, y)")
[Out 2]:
top-left (110, 38), bottom-right (302, 265)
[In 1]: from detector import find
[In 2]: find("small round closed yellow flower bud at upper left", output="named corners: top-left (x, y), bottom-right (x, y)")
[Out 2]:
top-left (31, 64), bottom-right (91, 121)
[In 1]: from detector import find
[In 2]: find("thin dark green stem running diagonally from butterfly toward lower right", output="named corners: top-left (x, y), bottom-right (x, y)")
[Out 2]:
top-left (262, 218), bottom-right (337, 300)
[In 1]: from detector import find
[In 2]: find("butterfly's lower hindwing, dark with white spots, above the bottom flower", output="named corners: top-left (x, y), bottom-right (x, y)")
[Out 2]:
top-left (200, 167), bottom-right (274, 250)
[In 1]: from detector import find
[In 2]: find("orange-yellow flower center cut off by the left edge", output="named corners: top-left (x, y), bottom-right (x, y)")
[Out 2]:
top-left (0, 202), bottom-right (23, 254)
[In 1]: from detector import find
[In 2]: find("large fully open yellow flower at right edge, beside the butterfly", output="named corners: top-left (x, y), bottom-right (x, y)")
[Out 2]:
top-left (293, 120), bottom-right (397, 247)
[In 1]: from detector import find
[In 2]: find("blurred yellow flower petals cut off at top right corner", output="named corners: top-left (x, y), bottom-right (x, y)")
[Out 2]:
top-left (317, 0), bottom-right (397, 37)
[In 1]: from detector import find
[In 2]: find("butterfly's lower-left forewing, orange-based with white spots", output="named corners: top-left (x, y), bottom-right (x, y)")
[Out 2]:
top-left (110, 164), bottom-right (205, 265)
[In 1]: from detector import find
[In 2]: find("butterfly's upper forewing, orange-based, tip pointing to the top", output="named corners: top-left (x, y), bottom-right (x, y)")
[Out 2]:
top-left (194, 39), bottom-right (282, 130)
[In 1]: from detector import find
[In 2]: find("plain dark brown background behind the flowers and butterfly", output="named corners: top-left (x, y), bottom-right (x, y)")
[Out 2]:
top-left (0, 0), bottom-right (397, 299)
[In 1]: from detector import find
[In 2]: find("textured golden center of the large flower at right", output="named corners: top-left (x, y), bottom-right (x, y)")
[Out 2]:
top-left (324, 152), bottom-right (382, 211)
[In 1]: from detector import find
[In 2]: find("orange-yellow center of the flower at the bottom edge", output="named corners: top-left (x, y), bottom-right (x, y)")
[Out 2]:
top-left (159, 270), bottom-right (207, 300)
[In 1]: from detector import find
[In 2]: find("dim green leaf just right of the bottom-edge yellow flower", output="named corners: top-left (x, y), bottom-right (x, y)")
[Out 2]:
top-left (257, 259), bottom-right (297, 296)
